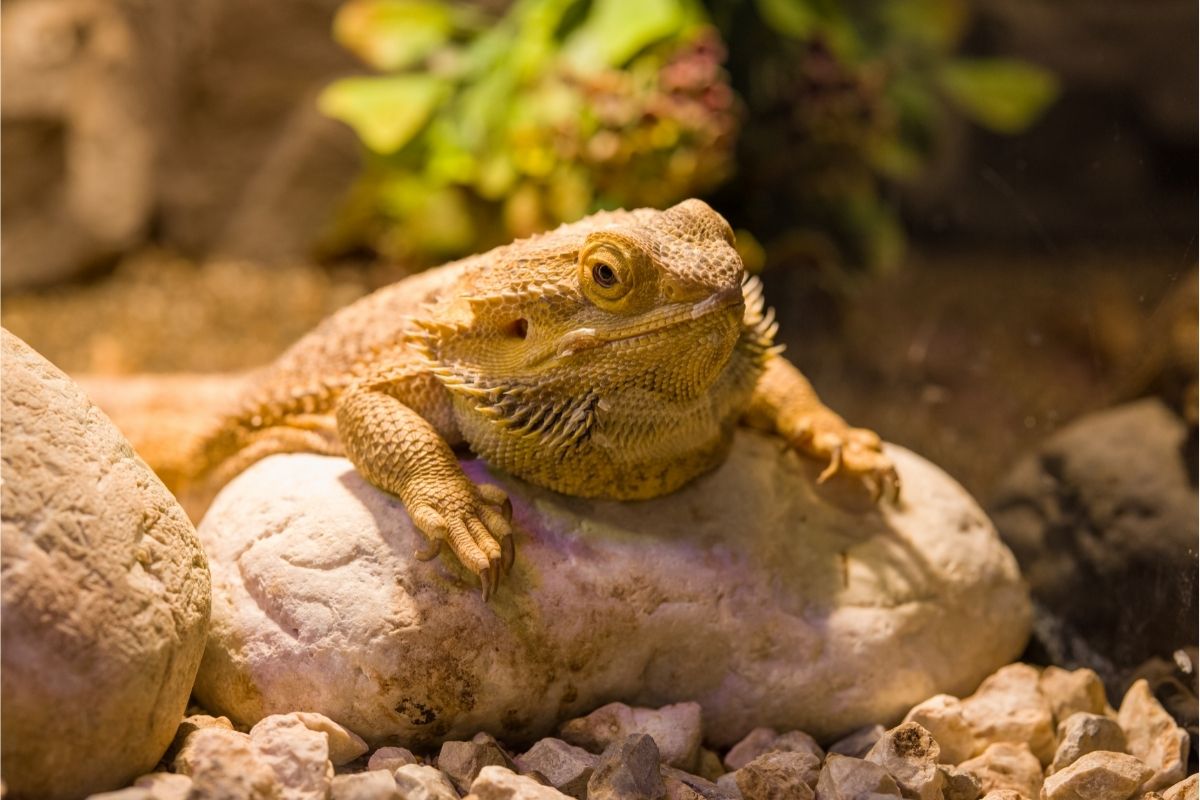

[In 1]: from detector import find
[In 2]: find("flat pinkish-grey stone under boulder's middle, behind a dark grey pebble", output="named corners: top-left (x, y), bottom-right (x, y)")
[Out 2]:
top-left (559, 703), bottom-right (702, 770)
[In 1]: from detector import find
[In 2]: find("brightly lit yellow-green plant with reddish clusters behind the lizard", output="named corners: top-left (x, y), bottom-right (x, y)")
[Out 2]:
top-left (319, 0), bottom-right (737, 265)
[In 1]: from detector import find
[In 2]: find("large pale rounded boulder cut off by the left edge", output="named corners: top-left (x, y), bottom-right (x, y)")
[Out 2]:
top-left (0, 331), bottom-right (209, 798)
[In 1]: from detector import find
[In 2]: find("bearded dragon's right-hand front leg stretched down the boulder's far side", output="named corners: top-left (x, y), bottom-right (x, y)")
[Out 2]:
top-left (744, 356), bottom-right (900, 501)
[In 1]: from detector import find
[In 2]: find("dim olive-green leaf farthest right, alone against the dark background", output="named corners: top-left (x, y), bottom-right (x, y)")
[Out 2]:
top-left (937, 59), bottom-right (1058, 133)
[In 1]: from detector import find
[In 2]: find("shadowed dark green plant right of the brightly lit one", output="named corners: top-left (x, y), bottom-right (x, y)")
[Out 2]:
top-left (712, 0), bottom-right (1057, 279)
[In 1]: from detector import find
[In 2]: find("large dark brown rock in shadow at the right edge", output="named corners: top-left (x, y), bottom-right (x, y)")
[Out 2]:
top-left (990, 402), bottom-right (1200, 690)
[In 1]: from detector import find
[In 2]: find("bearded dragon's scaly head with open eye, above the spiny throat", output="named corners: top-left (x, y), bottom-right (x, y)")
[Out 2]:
top-left (427, 200), bottom-right (745, 396)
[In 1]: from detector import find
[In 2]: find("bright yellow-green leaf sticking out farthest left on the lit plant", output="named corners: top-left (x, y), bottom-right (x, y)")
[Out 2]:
top-left (317, 76), bottom-right (446, 155)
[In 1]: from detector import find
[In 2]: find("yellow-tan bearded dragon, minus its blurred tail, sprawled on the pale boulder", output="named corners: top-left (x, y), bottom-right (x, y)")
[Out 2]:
top-left (189, 200), bottom-right (900, 601)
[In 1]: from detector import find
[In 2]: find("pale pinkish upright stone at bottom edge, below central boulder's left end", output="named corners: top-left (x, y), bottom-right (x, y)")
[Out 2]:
top-left (250, 714), bottom-right (334, 800)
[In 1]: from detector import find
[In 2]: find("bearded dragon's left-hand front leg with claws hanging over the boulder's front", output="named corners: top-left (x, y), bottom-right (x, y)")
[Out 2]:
top-left (337, 375), bottom-right (514, 602)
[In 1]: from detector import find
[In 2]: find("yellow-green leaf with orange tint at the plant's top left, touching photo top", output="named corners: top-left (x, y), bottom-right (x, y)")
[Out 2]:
top-left (334, 0), bottom-right (454, 72)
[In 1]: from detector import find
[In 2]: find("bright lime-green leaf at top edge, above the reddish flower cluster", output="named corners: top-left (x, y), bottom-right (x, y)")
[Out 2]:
top-left (563, 0), bottom-right (689, 72)
